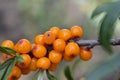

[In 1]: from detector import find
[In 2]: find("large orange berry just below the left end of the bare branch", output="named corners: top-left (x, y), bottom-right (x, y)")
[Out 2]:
top-left (65, 42), bottom-right (80, 57)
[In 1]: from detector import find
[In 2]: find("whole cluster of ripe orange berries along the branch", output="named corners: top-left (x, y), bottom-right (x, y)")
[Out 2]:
top-left (1, 26), bottom-right (92, 80)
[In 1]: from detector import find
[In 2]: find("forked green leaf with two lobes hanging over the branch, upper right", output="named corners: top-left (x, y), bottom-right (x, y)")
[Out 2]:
top-left (92, 1), bottom-right (120, 52)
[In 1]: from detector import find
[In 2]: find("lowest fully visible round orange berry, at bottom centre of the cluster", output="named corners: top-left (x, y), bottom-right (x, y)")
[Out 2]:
top-left (36, 57), bottom-right (51, 70)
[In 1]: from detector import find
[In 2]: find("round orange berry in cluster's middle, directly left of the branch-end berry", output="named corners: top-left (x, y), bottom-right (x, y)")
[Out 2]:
top-left (53, 39), bottom-right (66, 52)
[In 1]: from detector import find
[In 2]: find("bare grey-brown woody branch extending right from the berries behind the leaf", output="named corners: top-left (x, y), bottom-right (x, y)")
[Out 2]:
top-left (75, 39), bottom-right (120, 49)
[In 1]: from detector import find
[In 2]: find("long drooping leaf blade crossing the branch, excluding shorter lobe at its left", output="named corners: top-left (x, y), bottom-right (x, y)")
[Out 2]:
top-left (99, 1), bottom-right (120, 52)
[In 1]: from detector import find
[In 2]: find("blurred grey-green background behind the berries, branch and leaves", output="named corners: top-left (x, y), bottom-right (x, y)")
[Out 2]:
top-left (0, 0), bottom-right (120, 80)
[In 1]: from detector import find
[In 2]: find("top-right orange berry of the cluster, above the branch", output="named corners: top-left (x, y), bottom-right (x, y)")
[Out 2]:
top-left (70, 26), bottom-right (83, 38)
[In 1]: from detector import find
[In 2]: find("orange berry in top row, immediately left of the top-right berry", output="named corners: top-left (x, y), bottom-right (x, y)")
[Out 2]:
top-left (58, 29), bottom-right (72, 41)
